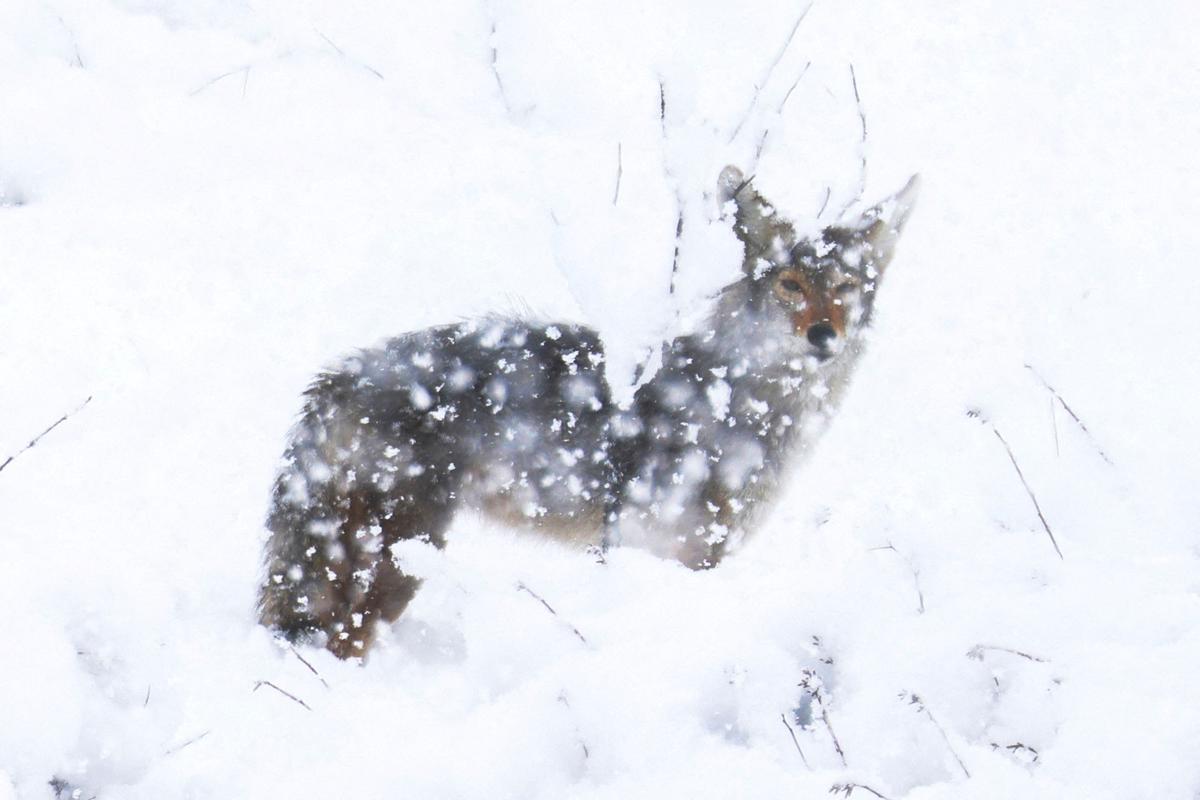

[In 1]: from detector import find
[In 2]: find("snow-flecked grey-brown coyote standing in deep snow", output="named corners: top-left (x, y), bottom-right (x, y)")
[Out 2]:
top-left (259, 167), bottom-right (917, 658)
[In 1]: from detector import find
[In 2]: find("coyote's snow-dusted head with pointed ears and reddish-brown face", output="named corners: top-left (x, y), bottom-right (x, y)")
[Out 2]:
top-left (719, 167), bottom-right (918, 362)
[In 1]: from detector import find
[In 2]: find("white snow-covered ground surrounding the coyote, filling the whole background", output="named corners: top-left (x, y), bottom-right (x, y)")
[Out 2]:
top-left (0, 0), bottom-right (1200, 800)
